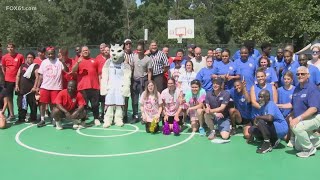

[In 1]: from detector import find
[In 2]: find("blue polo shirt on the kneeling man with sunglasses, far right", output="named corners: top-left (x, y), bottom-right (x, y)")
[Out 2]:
top-left (291, 82), bottom-right (320, 117)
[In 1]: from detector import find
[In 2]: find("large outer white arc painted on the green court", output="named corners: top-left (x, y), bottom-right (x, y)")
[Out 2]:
top-left (15, 125), bottom-right (195, 158)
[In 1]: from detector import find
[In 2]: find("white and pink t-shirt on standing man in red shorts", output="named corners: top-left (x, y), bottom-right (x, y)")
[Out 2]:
top-left (38, 58), bottom-right (64, 90)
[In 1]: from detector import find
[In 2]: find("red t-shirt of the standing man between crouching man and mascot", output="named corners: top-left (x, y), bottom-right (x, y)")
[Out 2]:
top-left (75, 58), bottom-right (100, 91)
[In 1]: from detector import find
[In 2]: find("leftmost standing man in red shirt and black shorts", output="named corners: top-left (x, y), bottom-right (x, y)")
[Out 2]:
top-left (1, 43), bottom-right (24, 120)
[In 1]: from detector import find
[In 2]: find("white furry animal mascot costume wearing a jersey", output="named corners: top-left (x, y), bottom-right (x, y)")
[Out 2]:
top-left (100, 44), bottom-right (131, 128)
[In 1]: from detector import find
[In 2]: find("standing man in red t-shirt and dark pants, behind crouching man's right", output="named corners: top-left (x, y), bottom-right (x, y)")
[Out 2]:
top-left (72, 46), bottom-right (101, 126)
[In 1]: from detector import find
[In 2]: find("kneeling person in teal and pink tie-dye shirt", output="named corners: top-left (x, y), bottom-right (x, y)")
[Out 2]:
top-left (185, 80), bottom-right (206, 133)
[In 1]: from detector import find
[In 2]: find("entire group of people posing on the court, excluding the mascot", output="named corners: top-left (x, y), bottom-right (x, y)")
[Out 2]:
top-left (0, 39), bottom-right (320, 157)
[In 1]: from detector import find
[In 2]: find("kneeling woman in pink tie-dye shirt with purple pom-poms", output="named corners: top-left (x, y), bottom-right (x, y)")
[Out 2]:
top-left (161, 78), bottom-right (183, 134)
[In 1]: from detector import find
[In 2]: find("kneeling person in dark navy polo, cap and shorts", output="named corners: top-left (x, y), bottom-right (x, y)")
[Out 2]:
top-left (204, 77), bottom-right (230, 140)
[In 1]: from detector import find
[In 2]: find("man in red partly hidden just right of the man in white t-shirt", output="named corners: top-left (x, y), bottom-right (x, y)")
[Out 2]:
top-left (58, 48), bottom-right (76, 89)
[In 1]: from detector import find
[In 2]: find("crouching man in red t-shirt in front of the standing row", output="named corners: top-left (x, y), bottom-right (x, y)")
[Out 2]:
top-left (52, 80), bottom-right (86, 130)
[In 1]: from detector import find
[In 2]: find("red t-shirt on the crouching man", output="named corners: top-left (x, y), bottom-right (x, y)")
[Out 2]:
top-left (55, 89), bottom-right (86, 111)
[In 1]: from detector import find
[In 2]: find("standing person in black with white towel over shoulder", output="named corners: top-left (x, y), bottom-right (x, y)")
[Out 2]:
top-left (15, 52), bottom-right (39, 124)
